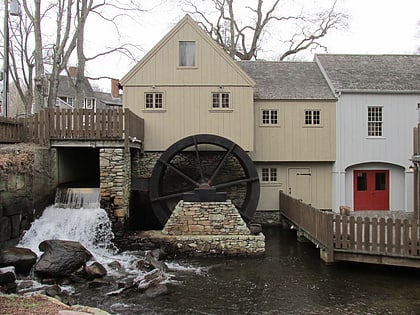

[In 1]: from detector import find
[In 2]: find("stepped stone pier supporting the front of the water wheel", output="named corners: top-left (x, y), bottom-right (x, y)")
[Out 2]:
top-left (155, 200), bottom-right (265, 256)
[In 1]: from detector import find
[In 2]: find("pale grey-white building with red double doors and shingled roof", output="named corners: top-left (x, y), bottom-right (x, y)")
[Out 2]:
top-left (315, 54), bottom-right (420, 211)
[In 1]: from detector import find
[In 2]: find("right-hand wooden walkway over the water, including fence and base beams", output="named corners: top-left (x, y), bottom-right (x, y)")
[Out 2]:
top-left (279, 192), bottom-right (420, 268)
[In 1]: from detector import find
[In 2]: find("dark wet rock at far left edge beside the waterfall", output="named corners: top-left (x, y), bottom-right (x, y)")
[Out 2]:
top-left (0, 247), bottom-right (38, 275)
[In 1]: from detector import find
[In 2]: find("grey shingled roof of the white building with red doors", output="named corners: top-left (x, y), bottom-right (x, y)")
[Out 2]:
top-left (315, 54), bottom-right (420, 92)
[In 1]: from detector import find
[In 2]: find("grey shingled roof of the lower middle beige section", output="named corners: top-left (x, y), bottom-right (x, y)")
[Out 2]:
top-left (238, 61), bottom-right (335, 100)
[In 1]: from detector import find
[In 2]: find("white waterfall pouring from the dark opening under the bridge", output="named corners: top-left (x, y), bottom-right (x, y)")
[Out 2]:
top-left (19, 188), bottom-right (114, 255)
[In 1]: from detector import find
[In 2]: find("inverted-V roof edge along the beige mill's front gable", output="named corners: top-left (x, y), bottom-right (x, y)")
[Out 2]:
top-left (120, 14), bottom-right (255, 86)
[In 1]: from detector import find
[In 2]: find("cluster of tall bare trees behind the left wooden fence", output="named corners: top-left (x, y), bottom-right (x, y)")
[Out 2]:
top-left (6, 0), bottom-right (148, 113)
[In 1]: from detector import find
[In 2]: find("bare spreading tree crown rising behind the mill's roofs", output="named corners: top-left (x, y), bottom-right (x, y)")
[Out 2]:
top-left (183, 0), bottom-right (348, 60)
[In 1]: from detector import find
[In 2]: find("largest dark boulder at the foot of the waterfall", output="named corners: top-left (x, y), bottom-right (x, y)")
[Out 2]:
top-left (35, 240), bottom-right (92, 277)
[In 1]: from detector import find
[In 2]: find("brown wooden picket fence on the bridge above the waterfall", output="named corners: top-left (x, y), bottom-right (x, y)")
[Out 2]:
top-left (0, 108), bottom-right (144, 151)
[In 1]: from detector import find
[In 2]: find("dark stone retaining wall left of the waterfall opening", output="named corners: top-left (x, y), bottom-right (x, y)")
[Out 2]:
top-left (0, 144), bottom-right (57, 248)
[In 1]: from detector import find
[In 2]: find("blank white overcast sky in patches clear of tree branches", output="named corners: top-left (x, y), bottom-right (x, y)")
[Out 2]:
top-left (84, 0), bottom-right (420, 90)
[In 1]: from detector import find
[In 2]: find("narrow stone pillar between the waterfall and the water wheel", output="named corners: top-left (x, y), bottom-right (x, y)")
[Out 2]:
top-left (99, 148), bottom-right (131, 236)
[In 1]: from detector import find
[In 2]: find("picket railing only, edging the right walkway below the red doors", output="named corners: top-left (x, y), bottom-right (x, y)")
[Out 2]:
top-left (280, 192), bottom-right (420, 259)
